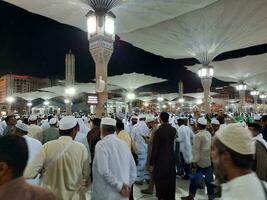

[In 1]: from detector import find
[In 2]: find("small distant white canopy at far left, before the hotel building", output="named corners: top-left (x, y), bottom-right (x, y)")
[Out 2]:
top-left (14, 91), bottom-right (60, 102)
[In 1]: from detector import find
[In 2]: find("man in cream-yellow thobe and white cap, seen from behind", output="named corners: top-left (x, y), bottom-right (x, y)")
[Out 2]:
top-left (24, 116), bottom-right (90, 200)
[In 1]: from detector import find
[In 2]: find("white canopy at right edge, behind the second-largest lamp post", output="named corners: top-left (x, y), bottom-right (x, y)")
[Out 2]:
top-left (187, 53), bottom-right (267, 90)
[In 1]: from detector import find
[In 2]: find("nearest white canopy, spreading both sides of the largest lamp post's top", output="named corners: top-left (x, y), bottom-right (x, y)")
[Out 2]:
top-left (5, 0), bottom-right (216, 33)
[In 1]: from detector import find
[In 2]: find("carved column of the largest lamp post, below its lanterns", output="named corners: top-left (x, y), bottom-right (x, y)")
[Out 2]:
top-left (89, 36), bottom-right (113, 117)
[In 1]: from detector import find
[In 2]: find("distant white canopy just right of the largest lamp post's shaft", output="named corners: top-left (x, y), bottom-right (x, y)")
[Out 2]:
top-left (108, 72), bottom-right (167, 92)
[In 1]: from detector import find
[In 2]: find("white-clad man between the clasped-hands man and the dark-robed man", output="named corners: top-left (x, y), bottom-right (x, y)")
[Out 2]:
top-left (131, 114), bottom-right (150, 185)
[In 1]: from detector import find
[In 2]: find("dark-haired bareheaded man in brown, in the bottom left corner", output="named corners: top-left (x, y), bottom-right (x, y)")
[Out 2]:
top-left (0, 135), bottom-right (55, 200)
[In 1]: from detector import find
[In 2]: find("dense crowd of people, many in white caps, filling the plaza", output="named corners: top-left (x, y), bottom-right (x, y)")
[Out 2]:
top-left (0, 112), bottom-right (267, 200)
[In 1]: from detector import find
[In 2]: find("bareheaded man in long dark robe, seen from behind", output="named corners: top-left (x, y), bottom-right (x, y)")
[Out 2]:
top-left (150, 112), bottom-right (176, 200)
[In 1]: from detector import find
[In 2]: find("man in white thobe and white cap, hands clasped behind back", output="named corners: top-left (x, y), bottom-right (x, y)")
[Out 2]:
top-left (92, 118), bottom-right (136, 200)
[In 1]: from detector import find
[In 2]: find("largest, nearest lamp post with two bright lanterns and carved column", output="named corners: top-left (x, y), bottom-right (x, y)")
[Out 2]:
top-left (86, 5), bottom-right (116, 117)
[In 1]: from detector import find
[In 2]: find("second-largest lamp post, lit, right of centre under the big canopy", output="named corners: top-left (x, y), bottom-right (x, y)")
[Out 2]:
top-left (198, 64), bottom-right (214, 113)
